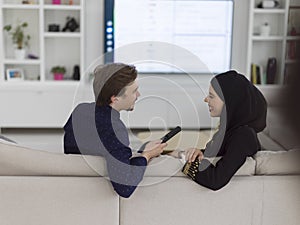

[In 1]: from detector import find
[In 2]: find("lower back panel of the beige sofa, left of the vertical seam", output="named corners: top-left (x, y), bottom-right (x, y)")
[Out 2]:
top-left (0, 176), bottom-right (119, 225)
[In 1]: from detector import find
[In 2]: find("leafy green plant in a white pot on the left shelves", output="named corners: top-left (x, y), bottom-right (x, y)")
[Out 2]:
top-left (3, 22), bottom-right (30, 59)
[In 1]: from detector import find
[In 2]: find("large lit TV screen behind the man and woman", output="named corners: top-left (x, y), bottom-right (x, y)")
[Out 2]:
top-left (104, 0), bottom-right (233, 73)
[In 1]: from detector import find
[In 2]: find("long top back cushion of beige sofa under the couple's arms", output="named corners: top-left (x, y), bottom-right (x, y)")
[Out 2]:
top-left (0, 141), bottom-right (255, 179)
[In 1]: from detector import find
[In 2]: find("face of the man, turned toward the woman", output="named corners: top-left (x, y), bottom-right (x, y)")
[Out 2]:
top-left (117, 81), bottom-right (141, 111)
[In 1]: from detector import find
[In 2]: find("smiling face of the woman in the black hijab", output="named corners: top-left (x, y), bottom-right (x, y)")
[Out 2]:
top-left (204, 85), bottom-right (224, 117)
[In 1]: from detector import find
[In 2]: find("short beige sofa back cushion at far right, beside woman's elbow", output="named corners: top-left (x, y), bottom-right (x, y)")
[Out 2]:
top-left (254, 149), bottom-right (300, 175)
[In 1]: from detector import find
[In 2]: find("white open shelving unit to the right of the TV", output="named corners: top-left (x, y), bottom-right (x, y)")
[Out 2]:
top-left (247, 0), bottom-right (300, 84)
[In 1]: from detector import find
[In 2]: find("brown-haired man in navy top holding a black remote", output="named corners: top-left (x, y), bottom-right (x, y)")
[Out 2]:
top-left (64, 63), bottom-right (166, 198)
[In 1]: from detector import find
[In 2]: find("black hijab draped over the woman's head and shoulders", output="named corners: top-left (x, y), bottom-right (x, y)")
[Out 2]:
top-left (205, 70), bottom-right (267, 156)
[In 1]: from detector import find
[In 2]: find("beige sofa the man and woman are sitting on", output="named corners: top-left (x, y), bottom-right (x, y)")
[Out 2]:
top-left (0, 86), bottom-right (300, 225)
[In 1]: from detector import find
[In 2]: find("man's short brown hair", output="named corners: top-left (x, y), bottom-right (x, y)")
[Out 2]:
top-left (93, 63), bottom-right (137, 106)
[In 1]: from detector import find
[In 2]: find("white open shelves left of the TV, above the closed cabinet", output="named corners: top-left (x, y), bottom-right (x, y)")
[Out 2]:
top-left (0, 0), bottom-right (84, 82)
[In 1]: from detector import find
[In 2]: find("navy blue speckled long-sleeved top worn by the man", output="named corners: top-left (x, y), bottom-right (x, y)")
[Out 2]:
top-left (64, 103), bottom-right (147, 198)
